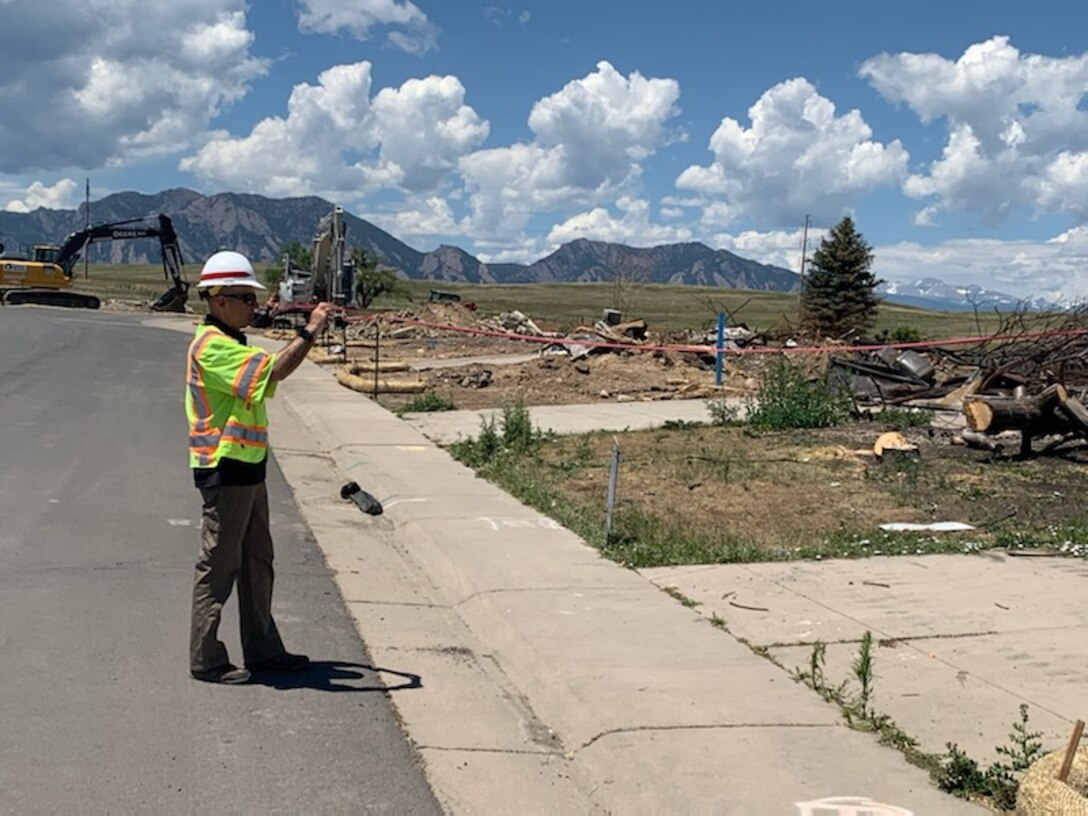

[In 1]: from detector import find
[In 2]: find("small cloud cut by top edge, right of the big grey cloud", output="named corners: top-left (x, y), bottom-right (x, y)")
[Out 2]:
top-left (298, 0), bottom-right (438, 54)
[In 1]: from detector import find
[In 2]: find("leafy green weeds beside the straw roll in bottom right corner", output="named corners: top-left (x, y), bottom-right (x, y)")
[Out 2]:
top-left (934, 704), bottom-right (1042, 811)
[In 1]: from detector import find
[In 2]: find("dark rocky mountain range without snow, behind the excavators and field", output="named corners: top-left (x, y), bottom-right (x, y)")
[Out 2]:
top-left (0, 188), bottom-right (800, 292)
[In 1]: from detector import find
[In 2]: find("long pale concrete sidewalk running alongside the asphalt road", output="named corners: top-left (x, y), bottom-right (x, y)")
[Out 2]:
top-left (256, 350), bottom-right (981, 814)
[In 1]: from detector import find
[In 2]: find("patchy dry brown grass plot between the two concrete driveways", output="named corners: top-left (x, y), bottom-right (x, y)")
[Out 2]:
top-left (452, 422), bottom-right (1088, 566)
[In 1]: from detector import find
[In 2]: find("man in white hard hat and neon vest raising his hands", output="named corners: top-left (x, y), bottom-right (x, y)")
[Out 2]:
top-left (185, 252), bottom-right (329, 684)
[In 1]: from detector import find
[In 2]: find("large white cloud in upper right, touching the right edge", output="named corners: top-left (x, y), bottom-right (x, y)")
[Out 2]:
top-left (860, 37), bottom-right (1088, 224)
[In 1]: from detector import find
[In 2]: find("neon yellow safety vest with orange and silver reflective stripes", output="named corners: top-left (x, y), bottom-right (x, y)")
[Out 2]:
top-left (185, 324), bottom-right (275, 468)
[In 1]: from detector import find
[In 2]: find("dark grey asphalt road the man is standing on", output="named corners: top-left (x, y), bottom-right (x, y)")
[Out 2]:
top-left (0, 307), bottom-right (441, 814)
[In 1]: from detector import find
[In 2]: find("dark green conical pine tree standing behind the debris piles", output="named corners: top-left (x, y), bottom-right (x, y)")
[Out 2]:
top-left (801, 215), bottom-right (883, 336)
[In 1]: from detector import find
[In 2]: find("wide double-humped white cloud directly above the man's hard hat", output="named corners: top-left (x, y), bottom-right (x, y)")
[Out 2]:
top-left (181, 61), bottom-right (487, 199)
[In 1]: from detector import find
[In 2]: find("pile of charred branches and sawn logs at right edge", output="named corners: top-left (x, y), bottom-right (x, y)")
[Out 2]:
top-left (829, 307), bottom-right (1088, 456)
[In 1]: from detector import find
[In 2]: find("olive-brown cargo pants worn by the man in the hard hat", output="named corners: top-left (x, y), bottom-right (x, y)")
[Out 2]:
top-left (189, 483), bottom-right (284, 671)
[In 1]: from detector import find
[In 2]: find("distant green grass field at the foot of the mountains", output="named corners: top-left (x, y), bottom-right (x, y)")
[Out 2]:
top-left (65, 264), bottom-right (999, 339)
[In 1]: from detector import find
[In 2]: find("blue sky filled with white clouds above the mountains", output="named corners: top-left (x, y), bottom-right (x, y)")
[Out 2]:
top-left (0, 0), bottom-right (1088, 299)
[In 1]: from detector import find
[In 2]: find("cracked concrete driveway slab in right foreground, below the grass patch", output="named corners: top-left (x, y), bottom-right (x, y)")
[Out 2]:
top-left (642, 551), bottom-right (1088, 768)
